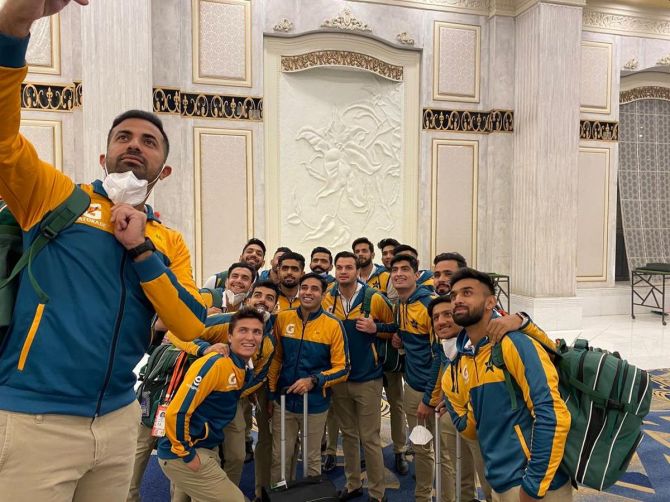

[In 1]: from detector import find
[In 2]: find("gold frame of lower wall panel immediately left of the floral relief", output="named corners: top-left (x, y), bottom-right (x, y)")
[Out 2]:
top-left (193, 127), bottom-right (254, 284)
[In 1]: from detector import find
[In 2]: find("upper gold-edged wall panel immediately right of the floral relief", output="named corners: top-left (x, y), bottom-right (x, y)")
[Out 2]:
top-left (433, 21), bottom-right (481, 103)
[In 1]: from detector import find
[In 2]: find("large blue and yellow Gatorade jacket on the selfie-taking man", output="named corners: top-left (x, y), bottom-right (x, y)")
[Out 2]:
top-left (0, 37), bottom-right (206, 417)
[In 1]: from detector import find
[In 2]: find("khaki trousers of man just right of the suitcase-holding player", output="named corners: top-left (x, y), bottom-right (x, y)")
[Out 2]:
top-left (332, 378), bottom-right (385, 500)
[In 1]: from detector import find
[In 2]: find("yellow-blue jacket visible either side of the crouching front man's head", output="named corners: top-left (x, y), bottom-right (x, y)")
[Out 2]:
top-left (168, 314), bottom-right (277, 397)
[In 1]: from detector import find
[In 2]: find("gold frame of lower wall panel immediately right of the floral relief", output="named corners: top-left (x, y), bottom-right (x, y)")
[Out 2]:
top-left (430, 138), bottom-right (479, 268)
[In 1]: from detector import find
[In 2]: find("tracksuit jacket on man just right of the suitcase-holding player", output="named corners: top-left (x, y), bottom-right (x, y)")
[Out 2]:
top-left (321, 284), bottom-right (393, 382)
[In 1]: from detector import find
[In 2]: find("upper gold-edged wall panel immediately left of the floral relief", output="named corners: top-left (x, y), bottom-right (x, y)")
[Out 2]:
top-left (191, 0), bottom-right (251, 87)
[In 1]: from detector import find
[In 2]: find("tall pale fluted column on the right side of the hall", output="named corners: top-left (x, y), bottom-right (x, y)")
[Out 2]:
top-left (511, 3), bottom-right (582, 329)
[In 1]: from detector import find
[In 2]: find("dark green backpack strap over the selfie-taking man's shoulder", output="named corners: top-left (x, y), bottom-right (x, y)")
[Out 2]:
top-left (0, 185), bottom-right (91, 303)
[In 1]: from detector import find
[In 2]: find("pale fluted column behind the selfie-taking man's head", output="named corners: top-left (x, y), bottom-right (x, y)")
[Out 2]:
top-left (76, 0), bottom-right (152, 185)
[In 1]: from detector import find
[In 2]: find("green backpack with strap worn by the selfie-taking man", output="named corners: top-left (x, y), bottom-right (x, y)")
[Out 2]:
top-left (0, 185), bottom-right (91, 340)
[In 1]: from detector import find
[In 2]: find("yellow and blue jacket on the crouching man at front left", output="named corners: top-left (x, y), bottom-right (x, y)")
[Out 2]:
top-left (157, 353), bottom-right (251, 462)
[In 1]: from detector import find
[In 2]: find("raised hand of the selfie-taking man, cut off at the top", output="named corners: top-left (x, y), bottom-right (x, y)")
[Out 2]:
top-left (0, 0), bottom-right (88, 38)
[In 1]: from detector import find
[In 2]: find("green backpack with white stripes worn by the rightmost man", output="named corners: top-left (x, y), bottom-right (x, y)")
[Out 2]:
top-left (491, 335), bottom-right (652, 490)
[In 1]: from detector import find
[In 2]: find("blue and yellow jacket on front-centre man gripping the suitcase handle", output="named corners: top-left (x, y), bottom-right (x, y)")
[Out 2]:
top-left (268, 308), bottom-right (350, 413)
